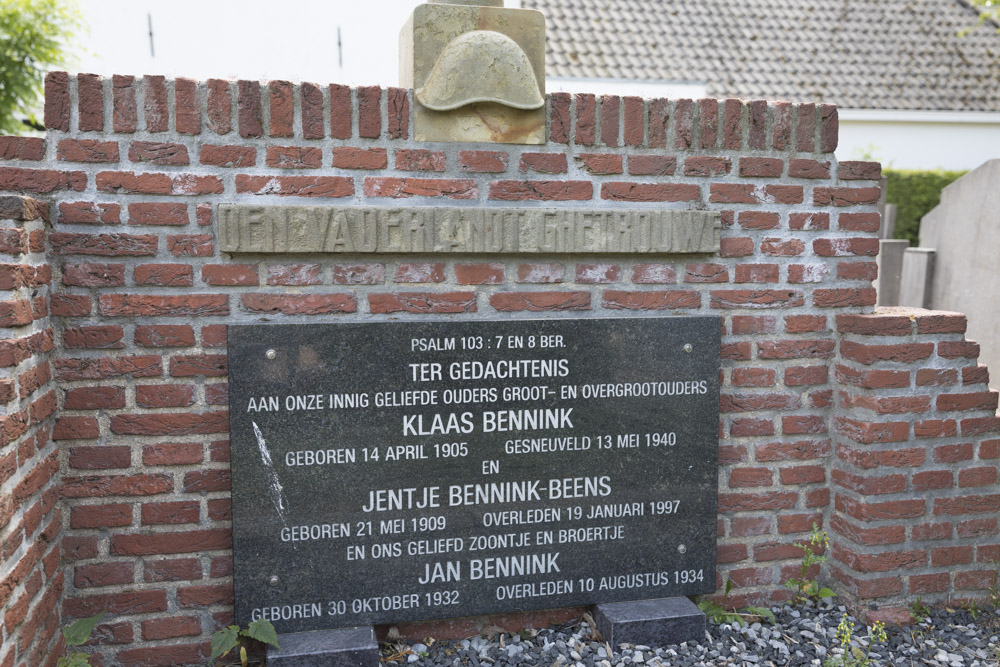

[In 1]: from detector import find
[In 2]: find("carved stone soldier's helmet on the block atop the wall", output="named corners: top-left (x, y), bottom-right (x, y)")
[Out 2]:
top-left (416, 30), bottom-right (545, 111)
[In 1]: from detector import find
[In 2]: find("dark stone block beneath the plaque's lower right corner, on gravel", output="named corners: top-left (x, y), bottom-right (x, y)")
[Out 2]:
top-left (594, 598), bottom-right (705, 648)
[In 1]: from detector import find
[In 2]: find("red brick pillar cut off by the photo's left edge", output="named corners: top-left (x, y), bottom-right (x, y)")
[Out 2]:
top-left (0, 196), bottom-right (63, 667)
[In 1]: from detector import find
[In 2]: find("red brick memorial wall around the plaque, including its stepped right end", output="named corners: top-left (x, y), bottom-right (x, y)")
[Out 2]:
top-left (0, 73), bottom-right (998, 665)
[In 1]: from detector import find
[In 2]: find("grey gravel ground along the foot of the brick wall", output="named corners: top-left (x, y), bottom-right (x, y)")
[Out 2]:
top-left (382, 601), bottom-right (1000, 667)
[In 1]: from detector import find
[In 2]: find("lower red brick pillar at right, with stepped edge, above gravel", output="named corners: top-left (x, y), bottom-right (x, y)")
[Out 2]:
top-left (830, 308), bottom-right (1000, 617)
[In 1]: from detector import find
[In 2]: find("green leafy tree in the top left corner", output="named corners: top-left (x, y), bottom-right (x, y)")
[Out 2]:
top-left (0, 0), bottom-right (81, 134)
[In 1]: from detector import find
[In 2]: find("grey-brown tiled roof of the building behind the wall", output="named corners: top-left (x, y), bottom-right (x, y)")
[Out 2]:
top-left (522, 0), bottom-right (1000, 112)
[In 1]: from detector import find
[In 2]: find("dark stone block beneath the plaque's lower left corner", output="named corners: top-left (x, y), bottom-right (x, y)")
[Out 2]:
top-left (267, 626), bottom-right (378, 667)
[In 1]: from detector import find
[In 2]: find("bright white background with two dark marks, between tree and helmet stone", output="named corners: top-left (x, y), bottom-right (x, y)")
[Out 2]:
top-left (72, 0), bottom-right (520, 86)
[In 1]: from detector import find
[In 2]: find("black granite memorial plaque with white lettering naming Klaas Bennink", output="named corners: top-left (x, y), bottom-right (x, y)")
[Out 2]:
top-left (229, 317), bottom-right (720, 633)
